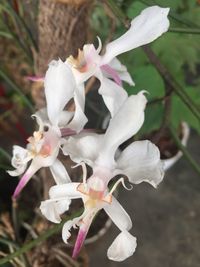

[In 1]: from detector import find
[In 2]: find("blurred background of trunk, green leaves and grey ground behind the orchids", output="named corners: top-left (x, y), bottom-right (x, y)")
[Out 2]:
top-left (0, 0), bottom-right (200, 267)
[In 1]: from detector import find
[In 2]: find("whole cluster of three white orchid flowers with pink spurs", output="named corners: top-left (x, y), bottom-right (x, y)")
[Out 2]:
top-left (9, 6), bottom-right (169, 261)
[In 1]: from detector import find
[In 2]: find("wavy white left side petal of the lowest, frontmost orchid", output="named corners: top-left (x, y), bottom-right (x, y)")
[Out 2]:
top-left (63, 133), bottom-right (103, 167)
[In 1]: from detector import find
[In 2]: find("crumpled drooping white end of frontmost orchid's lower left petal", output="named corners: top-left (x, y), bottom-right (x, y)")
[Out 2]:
top-left (40, 197), bottom-right (71, 223)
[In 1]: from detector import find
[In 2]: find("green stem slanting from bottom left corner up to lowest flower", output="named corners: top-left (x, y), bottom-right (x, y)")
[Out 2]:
top-left (0, 210), bottom-right (82, 265)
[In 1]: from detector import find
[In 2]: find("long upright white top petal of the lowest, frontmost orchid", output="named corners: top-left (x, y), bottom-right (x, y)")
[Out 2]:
top-left (97, 91), bottom-right (147, 168)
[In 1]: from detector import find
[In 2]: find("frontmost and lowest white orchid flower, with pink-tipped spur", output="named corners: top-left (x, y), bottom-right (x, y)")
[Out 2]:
top-left (40, 92), bottom-right (163, 261)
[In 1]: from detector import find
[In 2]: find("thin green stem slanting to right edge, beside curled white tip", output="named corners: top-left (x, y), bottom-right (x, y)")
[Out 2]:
top-left (169, 126), bottom-right (200, 178)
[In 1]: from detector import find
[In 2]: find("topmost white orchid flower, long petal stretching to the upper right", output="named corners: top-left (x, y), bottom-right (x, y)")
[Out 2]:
top-left (67, 6), bottom-right (169, 116)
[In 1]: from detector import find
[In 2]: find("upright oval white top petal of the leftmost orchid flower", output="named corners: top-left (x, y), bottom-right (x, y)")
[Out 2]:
top-left (44, 59), bottom-right (75, 125)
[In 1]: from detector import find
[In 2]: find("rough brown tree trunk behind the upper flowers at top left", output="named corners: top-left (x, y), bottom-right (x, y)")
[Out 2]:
top-left (32, 0), bottom-right (91, 108)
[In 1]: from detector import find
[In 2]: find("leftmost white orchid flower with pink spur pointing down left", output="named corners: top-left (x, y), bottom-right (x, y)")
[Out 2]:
top-left (8, 60), bottom-right (87, 198)
